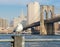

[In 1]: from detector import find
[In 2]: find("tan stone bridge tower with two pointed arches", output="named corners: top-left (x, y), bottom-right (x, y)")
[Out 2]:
top-left (40, 5), bottom-right (54, 35)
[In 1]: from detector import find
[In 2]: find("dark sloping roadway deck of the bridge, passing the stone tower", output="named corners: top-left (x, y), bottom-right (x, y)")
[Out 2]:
top-left (24, 17), bottom-right (60, 30)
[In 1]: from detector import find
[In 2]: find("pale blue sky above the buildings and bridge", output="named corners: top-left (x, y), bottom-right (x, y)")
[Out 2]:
top-left (0, 0), bottom-right (60, 21)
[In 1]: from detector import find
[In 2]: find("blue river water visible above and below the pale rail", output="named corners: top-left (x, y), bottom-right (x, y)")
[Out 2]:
top-left (0, 34), bottom-right (60, 47)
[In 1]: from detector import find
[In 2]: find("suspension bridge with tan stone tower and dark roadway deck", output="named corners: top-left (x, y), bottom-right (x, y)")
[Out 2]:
top-left (23, 5), bottom-right (60, 35)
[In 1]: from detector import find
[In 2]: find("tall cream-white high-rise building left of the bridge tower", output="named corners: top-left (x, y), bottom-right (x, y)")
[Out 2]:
top-left (27, 2), bottom-right (40, 24)
